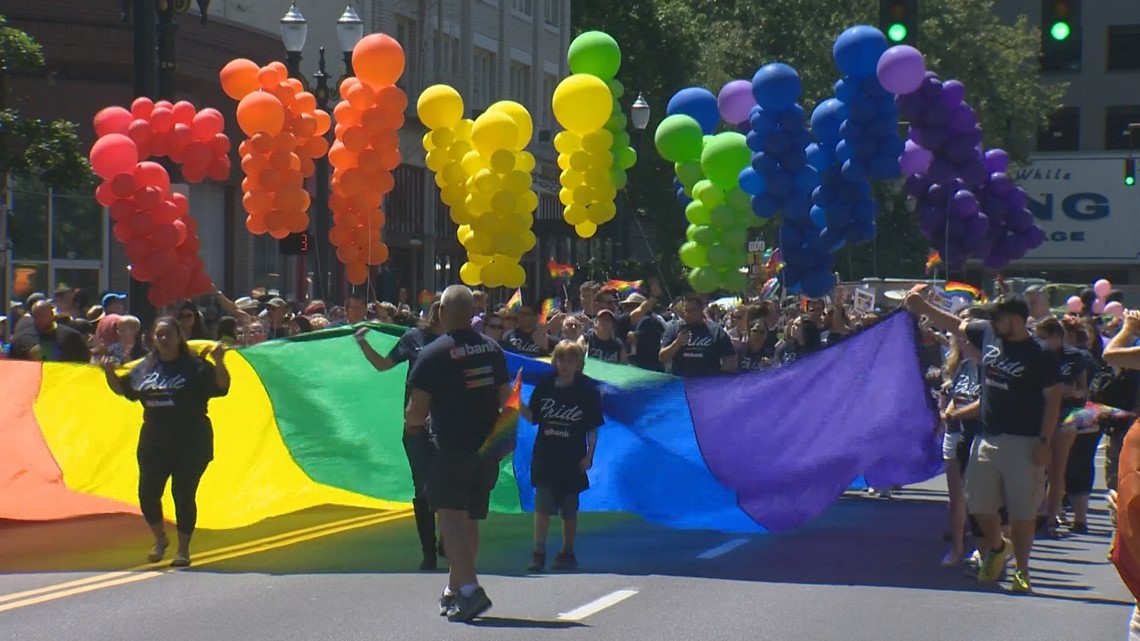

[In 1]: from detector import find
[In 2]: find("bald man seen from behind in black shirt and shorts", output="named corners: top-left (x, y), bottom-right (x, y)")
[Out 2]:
top-left (406, 285), bottom-right (511, 622)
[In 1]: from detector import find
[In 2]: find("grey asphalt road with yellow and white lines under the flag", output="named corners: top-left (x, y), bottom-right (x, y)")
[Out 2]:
top-left (0, 481), bottom-right (1132, 641)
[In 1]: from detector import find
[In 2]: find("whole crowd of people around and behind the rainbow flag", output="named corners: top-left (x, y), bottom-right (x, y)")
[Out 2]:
top-left (0, 277), bottom-right (1140, 620)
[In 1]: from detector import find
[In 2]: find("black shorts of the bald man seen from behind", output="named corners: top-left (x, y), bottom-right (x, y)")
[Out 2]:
top-left (428, 449), bottom-right (499, 520)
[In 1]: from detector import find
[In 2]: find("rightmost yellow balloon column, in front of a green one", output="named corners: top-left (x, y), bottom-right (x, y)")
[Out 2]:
top-left (553, 55), bottom-right (620, 238)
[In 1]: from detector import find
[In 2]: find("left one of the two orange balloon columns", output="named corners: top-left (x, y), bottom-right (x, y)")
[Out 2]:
top-left (218, 58), bottom-right (331, 238)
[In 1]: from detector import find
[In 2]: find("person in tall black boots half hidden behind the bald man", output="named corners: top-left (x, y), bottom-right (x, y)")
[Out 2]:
top-left (356, 301), bottom-right (442, 570)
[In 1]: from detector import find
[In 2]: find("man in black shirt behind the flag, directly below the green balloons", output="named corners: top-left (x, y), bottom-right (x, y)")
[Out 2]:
top-left (659, 294), bottom-right (736, 376)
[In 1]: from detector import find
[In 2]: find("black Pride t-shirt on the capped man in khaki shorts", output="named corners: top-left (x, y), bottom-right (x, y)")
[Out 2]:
top-left (966, 321), bottom-right (1060, 436)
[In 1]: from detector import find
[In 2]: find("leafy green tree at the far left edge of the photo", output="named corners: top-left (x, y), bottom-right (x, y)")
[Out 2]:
top-left (0, 15), bottom-right (91, 306)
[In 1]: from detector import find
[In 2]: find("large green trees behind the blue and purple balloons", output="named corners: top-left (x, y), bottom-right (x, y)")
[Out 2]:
top-left (573, 0), bottom-right (1065, 284)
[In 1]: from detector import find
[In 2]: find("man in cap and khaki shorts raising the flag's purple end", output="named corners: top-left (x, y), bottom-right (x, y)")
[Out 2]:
top-left (905, 292), bottom-right (1064, 592)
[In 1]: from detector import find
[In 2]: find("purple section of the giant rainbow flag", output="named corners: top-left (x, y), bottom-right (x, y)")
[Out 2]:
top-left (685, 313), bottom-right (943, 530)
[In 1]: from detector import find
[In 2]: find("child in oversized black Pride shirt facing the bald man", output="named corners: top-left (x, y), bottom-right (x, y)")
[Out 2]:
top-left (521, 341), bottom-right (604, 571)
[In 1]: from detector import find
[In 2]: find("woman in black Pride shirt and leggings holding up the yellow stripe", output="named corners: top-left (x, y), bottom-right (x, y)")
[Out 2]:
top-left (104, 317), bottom-right (229, 568)
